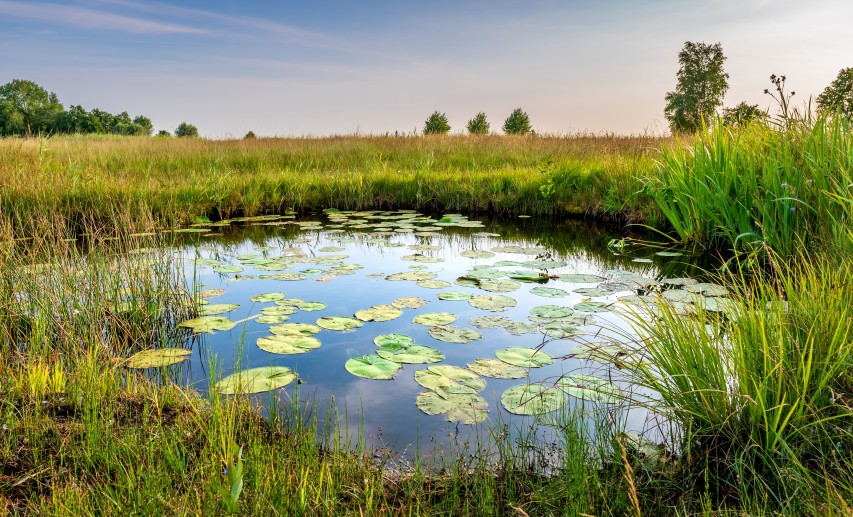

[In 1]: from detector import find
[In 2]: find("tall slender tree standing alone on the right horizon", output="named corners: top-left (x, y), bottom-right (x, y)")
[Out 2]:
top-left (664, 41), bottom-right (729, 133)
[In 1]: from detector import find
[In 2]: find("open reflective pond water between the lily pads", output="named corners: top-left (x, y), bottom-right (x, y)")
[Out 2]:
top-left (163, 212), bottom-right (711, 453)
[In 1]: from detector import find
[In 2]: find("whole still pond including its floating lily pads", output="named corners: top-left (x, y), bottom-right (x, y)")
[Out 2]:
top-left (136, 210), bottom-right (714, 452)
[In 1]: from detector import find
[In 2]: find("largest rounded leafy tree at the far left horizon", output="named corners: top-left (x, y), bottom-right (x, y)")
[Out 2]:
top-left (0, 79), bottom-right (63, 136)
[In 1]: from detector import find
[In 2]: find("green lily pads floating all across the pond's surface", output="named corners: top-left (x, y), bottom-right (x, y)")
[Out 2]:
top-left (121, 210), bottom-right (730, 424)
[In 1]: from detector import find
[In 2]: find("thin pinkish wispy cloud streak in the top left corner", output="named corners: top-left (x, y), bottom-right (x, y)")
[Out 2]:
top-left (0, 0), bottom-right (206, 34)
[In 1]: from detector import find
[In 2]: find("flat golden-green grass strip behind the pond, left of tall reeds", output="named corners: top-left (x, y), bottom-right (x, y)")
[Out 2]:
top-left (0, 136), bottom-right (670, 237)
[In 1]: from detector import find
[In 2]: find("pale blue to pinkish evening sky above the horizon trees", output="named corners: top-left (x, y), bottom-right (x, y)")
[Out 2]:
top-left (0, 0), bottom-right (853, 138)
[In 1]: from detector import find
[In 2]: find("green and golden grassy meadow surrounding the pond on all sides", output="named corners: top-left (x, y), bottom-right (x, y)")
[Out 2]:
top-left (0, 118), bottom-right (853, 516)
